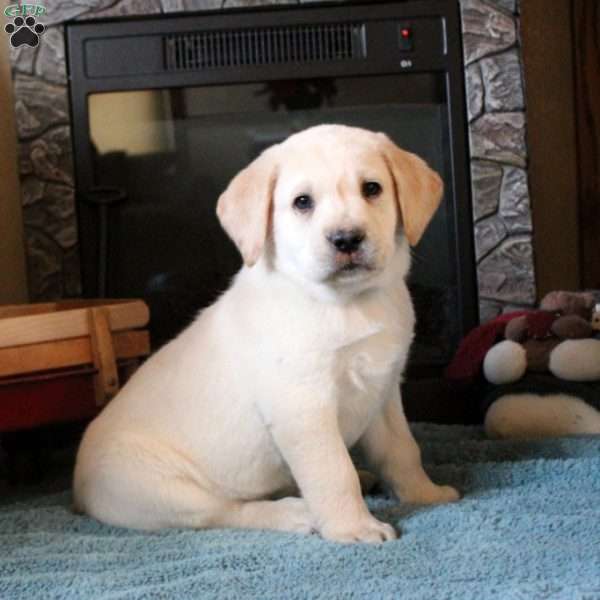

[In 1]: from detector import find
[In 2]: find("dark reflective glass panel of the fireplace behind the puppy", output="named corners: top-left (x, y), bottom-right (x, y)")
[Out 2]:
top-left (88, 74), bottom-right (459, 365)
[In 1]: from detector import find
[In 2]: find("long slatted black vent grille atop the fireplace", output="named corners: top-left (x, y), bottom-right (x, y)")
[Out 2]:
top-left (164, 23), bottom-right (366, 71)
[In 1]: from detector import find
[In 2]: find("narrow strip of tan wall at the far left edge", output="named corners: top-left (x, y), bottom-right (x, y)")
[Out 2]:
top-left (0, 32), bottom-right (27, 304)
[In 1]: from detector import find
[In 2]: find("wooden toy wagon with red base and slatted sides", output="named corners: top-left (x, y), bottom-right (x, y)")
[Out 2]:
top-left (0, 300), bottom-right (150, 432)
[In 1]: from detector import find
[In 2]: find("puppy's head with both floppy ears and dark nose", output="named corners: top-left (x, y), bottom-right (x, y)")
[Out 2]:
top-left (217, 125), bottom-right (442, 289)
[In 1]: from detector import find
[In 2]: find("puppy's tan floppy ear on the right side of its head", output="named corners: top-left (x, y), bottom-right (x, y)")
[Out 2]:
top-left (377, 133), bottom-right (444, 246)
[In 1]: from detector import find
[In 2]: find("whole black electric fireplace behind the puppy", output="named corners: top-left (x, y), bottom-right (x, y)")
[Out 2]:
top-left (66, 0), bottom-right (478, 373)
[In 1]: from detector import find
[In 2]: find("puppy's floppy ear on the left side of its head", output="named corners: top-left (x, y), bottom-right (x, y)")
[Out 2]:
top-left (217, 146), bottom-right (277, 267)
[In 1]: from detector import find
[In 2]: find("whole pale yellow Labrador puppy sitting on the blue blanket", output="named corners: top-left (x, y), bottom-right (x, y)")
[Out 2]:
top-left (74, 125), bottom-right (458, 542)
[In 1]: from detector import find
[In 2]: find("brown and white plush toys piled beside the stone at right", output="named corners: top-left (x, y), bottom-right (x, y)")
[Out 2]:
top-left (446, 292), bottom-right (600, 438)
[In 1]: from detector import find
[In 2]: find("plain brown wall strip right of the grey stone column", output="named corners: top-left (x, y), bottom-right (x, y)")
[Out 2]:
top-left (521, 0), bottom-right (581, 299)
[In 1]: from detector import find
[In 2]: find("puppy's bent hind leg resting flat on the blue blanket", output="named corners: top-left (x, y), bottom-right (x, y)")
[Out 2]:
top-left (75, 439), bottom-right (314, 533)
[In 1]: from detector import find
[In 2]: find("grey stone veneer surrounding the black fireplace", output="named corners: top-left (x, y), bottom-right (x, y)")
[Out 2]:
top-left (11, 0), bottom-right (535, 319)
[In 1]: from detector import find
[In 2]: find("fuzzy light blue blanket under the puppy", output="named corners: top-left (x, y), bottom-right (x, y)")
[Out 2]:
top-left (0, 425), bottom-right (600, 600)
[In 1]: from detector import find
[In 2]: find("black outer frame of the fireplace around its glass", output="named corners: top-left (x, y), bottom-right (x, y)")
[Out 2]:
top-left (65, 0), bottom-right (478, 346)
